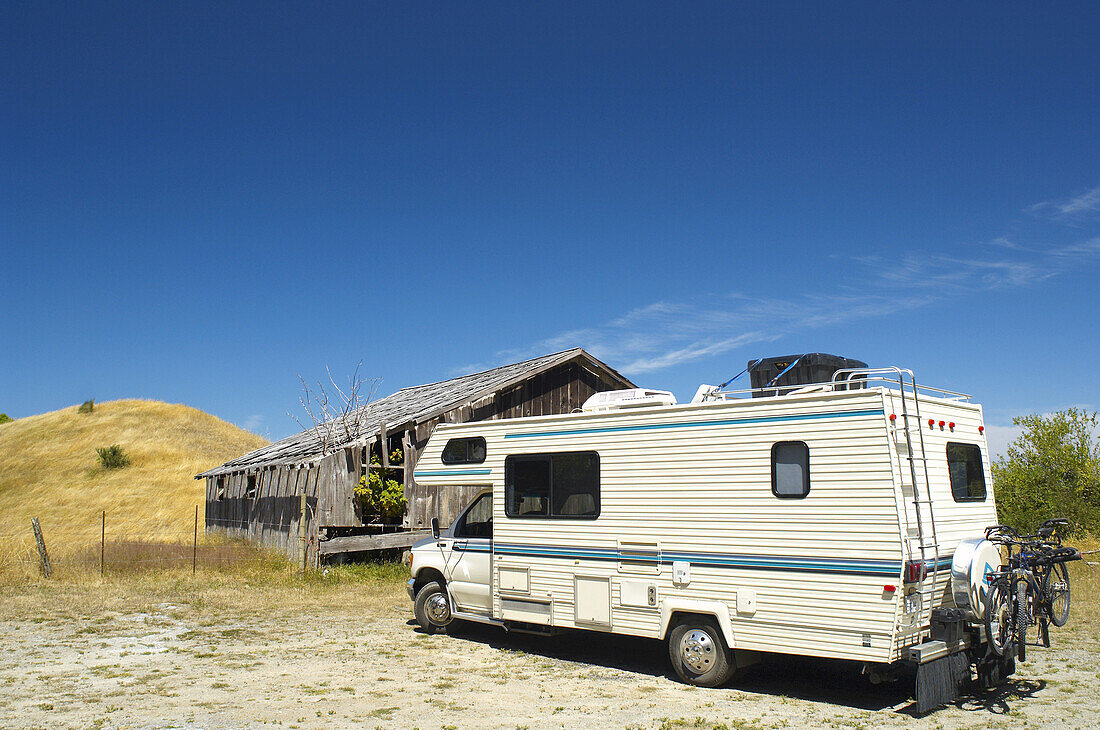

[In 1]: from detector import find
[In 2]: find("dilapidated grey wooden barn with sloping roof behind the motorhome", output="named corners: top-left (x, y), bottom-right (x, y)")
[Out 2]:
top-left (195, 349), bottom-right (635, 564)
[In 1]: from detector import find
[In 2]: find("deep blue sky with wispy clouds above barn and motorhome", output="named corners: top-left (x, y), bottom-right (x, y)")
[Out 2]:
top-left (0, 2), bottom-right (1100, 452)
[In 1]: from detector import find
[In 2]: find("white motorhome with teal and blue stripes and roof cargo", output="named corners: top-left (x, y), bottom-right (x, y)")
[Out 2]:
top-left (408, 368), bottom-right (1012, 705)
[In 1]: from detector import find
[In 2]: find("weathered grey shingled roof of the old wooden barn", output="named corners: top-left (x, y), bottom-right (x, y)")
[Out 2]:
top-left (195, 347), bottom-right (634, 479)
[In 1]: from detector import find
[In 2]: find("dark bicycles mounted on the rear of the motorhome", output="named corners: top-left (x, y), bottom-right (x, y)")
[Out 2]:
top-left (983, 519), bottom-right (1081, 661)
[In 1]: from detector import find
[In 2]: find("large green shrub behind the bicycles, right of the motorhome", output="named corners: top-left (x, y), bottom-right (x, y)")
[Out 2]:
top-left (993, 408), bottom-right (1100, 534)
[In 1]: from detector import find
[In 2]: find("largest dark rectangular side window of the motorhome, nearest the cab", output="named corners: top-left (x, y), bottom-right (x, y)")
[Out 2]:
top-left (504, 451), bottom-right (600, 520)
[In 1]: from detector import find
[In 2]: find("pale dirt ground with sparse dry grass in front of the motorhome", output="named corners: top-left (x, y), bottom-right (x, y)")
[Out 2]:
top-left (0, 585), bottom-right (1100, 730)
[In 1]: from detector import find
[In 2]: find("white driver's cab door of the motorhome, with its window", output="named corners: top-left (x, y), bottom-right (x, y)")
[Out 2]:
top-left (447, 493), bottom-right (493, 615)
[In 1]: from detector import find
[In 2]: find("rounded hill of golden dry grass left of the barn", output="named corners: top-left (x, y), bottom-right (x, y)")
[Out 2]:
top-left (0, 400), bottom-right (267, 554)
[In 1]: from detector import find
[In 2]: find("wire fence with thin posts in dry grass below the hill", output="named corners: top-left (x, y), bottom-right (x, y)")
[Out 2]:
top-left (0, 508), bottom-right (286, 577)
